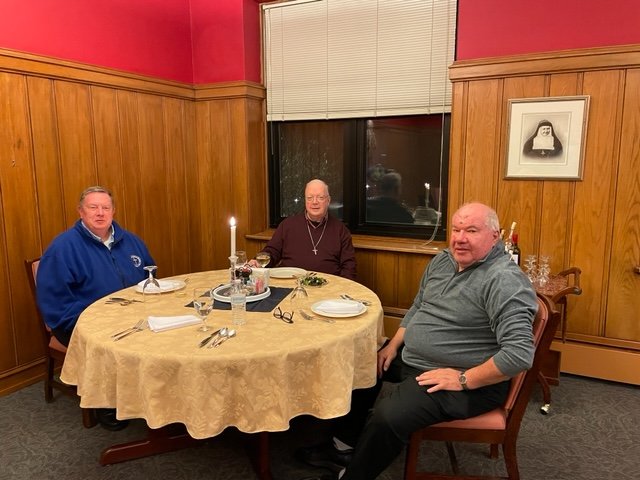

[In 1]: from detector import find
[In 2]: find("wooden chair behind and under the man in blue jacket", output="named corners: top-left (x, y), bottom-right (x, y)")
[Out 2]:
top-left (24, 258), bottom-right (97, 428)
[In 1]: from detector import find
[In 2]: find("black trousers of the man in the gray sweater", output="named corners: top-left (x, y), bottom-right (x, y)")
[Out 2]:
top-left (336, 352), bottom-right (509, 480)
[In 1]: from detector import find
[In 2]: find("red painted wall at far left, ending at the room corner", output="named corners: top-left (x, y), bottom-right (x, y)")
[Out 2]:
top-left (0, 0), bottom-right (195, 83)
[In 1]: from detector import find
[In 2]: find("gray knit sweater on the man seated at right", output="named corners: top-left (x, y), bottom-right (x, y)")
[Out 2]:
top-left (400, 242), bottom-right (538, 377)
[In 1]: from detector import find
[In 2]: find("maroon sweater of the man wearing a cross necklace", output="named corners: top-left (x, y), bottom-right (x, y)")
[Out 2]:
top-left (264, 213), bottom-right (356, 280)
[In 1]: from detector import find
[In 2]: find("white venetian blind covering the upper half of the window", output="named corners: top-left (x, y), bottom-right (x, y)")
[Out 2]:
top-left (262, 0), bottom-right (456, 120)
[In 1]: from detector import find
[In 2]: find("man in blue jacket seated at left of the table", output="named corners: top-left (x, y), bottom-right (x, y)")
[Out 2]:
top-left (36, 186), bottom-right (155, 430)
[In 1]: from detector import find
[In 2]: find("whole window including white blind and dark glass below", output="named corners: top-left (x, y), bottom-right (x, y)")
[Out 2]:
top-left (262, 0), bottom-right (457, 239)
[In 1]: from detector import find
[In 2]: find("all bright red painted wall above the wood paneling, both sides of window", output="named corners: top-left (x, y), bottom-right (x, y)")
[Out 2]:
top-left (0, 0), bottom-right (640, 84)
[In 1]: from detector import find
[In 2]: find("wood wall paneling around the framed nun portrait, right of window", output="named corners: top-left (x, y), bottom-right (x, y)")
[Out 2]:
top-left (450, 45), bottom-right (640, 383)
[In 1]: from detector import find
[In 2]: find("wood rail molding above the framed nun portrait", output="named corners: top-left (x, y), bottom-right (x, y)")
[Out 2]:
top-left (449, 44), bottom-right (640, 82)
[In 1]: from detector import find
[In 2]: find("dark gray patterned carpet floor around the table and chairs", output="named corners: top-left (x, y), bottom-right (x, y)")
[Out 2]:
top-left (0, 375), bottom-right (640, 480)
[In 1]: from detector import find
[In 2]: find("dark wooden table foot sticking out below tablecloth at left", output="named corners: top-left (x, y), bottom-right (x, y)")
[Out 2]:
top-left (100, 425), bottom-right (199, 465)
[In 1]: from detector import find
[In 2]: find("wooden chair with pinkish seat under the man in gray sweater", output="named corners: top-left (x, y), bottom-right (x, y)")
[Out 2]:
top-left (404, 294), bottom-right (560, 480)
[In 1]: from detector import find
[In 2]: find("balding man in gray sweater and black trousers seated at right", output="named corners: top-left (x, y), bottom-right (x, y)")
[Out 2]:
top-left (297, 203), bottom-right (538, 480)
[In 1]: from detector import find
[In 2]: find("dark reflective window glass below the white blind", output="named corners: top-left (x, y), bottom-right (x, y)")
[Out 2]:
top-left (269, 114), bottom-right (450, 240)
